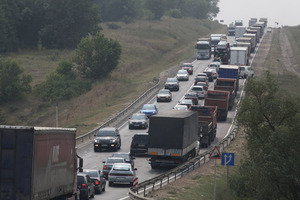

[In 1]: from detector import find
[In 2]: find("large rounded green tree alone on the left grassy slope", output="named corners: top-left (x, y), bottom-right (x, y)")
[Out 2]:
top-left (74, 33), bottom-right (122, 79)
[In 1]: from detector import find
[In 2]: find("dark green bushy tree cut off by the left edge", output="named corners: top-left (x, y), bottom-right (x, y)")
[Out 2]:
top-left (0, 58), bottom-right (32, 103)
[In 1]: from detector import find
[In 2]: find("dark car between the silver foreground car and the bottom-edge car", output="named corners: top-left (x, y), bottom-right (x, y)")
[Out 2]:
top-left (81, 169), bottom-right (106, 194)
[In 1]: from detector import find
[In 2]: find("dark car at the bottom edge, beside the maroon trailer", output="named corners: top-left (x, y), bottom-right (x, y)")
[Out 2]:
top-left (77, 173), bottom-right (95, 200)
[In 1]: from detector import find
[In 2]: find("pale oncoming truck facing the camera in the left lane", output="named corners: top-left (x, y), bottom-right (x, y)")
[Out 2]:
top-left (195, 38), bottom-right (211, 60)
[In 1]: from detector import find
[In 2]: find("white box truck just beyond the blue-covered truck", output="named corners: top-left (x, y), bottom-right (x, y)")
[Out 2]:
top-left (230, 47), bottom-right (249, 66)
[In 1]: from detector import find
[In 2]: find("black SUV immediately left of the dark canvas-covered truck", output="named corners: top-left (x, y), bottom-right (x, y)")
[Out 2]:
top-left (130, 133), bottom-right (149, 156)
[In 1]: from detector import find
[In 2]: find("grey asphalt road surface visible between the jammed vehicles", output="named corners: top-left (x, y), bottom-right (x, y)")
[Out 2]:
top-left (77, 35), bottom-right (253, 200)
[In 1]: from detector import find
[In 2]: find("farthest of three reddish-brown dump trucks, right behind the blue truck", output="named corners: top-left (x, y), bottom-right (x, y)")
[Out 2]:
top-left (214, 78), bottom-right (237, 110)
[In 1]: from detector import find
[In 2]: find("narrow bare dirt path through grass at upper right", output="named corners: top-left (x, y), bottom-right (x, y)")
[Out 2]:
top-left (279, 28), bottom-right (300, 76)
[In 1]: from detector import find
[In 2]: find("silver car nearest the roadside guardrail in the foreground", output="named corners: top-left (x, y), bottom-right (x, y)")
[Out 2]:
top-left (108, 163), bottom-right (137, 186)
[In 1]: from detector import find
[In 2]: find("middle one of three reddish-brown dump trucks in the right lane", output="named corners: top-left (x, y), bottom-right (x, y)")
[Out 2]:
top-left (204, 90), bottom-right (229, 121)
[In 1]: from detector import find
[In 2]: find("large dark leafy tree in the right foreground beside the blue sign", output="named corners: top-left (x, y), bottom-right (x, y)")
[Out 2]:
top-left (231, 72), bottom-right (300, 200)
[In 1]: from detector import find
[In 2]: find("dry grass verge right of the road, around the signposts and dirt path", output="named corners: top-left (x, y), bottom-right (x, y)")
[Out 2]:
top-left (154, 26), bottom-right (300, 200)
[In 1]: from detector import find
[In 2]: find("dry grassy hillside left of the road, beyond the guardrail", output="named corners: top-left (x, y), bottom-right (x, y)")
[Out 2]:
top-left (1, 17), bottom-right (225, 135)
